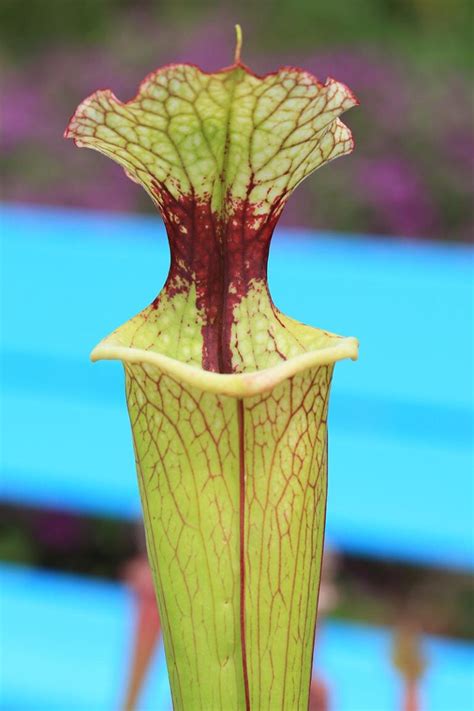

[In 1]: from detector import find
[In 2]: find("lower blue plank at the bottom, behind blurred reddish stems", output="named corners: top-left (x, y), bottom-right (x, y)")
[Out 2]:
top-left (0, 566), bottom-right (474, 711)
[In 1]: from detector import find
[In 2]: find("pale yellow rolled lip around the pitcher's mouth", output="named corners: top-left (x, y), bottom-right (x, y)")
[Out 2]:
top-left (90, 337), bottom-right (359, 399)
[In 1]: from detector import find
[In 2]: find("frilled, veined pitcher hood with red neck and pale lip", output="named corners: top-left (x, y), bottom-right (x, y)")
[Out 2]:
top-left (65, 29), bottom-right (358, 397)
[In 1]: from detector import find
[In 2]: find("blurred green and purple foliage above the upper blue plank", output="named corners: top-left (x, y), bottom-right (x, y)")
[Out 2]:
top-left (0, 0), bottom-right (474, 241)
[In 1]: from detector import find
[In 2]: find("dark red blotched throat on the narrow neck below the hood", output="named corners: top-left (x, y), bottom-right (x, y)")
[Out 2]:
top-left (155, 184), bottom-right (283, 373)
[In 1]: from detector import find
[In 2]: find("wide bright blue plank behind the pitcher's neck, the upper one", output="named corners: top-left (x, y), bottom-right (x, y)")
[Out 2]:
top-left (0, 206), bottom-right (474, 567)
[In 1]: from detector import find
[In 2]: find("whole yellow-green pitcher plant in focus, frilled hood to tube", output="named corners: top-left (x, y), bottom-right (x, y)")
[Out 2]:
top-left (66, 32), bottom-right (357, 711)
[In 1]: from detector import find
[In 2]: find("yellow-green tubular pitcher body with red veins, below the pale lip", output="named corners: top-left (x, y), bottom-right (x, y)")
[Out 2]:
top-left (126, 364), bottom-right (332, 711)
